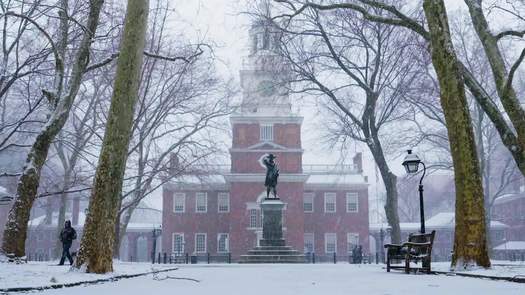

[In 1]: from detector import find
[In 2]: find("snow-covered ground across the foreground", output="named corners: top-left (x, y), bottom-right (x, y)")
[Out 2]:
top-left (0, 263), bottom-right (525, 295)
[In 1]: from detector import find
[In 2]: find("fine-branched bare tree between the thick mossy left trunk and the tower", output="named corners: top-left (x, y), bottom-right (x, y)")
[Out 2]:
top-left (114, 1), bottom-right (231, 257)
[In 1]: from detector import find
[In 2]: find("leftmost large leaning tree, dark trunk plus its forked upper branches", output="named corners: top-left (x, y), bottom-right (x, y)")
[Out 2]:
top-left (2, 0), bottom-right (103, 258)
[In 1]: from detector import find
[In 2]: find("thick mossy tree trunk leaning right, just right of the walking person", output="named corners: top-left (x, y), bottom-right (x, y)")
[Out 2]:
top-left (76, 0), bottom-right (149, 273)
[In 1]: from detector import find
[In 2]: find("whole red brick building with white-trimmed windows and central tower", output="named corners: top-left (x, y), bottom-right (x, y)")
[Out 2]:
top-left (162, 23), bottom-right (368, 258)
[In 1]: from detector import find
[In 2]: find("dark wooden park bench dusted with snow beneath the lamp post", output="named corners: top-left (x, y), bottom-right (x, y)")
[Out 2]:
top-left (385, 230), bottom-right (436, 273)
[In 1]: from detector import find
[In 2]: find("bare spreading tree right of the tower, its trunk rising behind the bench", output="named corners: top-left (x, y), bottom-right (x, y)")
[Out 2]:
top-left (264, 1), bottom-right (416, 242)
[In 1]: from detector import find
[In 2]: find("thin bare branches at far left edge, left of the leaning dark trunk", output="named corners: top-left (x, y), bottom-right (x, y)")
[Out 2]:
top-left (0, 0), bottom-right (53, 163)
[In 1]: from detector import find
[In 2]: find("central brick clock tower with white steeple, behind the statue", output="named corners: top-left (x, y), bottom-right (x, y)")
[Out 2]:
top-left (225, 21), bottom-right (308, 253)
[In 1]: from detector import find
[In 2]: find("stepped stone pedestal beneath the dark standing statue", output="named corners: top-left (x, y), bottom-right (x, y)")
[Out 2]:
top-left (239, 199), bottom-right (306, 263)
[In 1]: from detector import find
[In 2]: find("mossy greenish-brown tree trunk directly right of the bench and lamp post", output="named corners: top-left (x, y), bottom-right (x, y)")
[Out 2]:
top-left (423, 0), bottom-right (490, 269)
